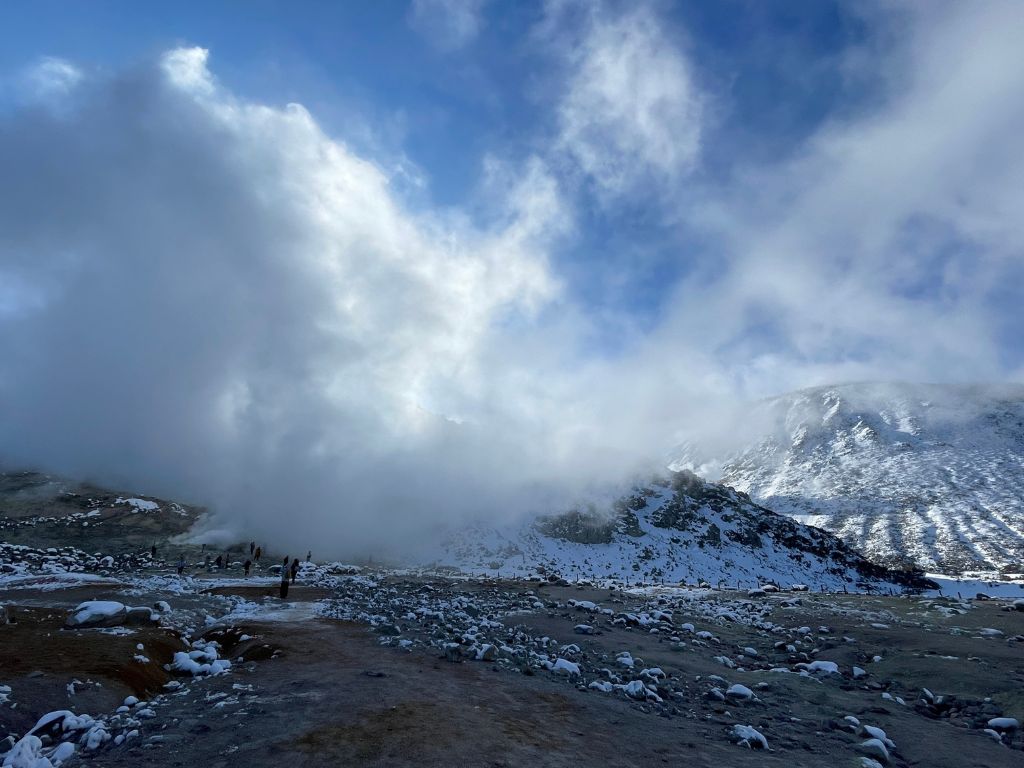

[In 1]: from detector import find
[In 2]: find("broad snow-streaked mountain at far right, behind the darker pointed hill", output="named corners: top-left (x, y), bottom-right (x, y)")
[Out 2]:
top-left (672, 384), bottom-right (1024, 571)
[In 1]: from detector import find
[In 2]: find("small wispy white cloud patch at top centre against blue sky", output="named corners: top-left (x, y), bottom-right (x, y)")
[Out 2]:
top-left (549, 5), bottom-right (703, 195)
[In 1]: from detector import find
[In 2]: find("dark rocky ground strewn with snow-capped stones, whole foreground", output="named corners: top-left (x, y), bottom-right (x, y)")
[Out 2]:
top-left (0, 473), bottom-right (1024, 768)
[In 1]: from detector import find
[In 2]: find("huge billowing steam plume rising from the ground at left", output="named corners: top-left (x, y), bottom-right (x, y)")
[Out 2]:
top-left (0, 49), bottom-right (696, 554)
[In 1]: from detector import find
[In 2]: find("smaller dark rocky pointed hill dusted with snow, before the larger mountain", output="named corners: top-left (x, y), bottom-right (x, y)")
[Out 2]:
top-left (428, 471), bottom-right (923, 590)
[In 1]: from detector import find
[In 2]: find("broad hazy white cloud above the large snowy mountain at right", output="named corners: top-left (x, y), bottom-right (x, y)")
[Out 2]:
top-left (662, 4), bottom-right (1024, 393)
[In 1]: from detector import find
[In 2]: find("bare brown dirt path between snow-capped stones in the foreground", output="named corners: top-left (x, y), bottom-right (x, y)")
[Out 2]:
top-left (90, 621), bottom-right (790, 768)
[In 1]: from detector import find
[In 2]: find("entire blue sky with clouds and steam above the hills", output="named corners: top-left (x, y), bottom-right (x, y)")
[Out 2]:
top-left (0, 0), bottom-right (1024, 547)
